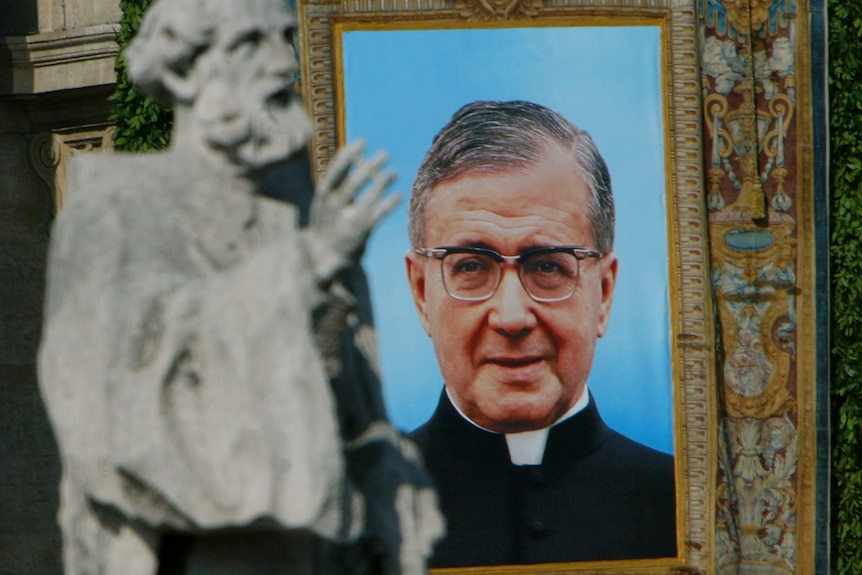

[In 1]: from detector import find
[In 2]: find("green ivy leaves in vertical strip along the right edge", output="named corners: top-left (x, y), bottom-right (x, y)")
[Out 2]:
top-left (827, 0), bottom-right (862, 575)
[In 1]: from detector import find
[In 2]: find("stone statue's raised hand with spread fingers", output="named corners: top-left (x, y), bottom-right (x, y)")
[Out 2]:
top-left (308, 140), bottom-right (400, 283)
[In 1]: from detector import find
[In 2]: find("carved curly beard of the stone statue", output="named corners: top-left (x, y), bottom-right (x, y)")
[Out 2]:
top-left (194, 81), bottom-right (311, 171)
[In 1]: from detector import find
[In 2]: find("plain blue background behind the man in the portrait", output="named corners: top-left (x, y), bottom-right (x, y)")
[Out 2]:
top-left (342, 26), bottom-right (673, 453)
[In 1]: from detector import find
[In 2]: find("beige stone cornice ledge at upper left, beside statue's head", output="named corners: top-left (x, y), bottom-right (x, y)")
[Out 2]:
top-left (0, 24), bottom-right (119, 95)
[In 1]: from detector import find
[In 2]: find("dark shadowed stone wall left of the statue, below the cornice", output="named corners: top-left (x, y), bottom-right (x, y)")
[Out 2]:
top-left (0, 64), bottom-right (115, 575)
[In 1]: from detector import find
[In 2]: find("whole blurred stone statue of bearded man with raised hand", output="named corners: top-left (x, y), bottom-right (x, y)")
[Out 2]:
top-left (39, 0), bottom-right (442, 575)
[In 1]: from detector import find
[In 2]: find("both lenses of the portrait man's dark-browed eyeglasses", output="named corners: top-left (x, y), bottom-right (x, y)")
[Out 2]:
top-left (443, 252), bottom-right (579, 301)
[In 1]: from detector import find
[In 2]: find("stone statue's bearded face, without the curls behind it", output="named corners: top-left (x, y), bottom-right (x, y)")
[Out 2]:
top-left (194, 0), bottom-right (311, 169)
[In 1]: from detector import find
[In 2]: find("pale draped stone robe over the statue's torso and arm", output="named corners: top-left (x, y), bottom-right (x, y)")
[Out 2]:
top-left (39, 152), bottom-right (361, 572)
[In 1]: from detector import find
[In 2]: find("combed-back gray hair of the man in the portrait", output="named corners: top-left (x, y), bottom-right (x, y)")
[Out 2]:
top-left (409, 101), bottom-right (615, 253)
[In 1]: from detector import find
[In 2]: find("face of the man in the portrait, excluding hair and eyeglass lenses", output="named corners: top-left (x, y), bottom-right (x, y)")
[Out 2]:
top-left (407, 146), bottom-right (617, 433)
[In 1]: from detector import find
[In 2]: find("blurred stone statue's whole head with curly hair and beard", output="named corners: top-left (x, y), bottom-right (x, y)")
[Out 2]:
top-left (125, 0), bottom-right (311, 171)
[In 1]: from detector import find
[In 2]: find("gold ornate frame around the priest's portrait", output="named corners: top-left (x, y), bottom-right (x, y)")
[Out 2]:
top-left (298, 0), bottom-right (717, 575)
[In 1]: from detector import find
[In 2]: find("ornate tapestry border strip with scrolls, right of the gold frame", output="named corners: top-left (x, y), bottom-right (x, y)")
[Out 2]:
top-left (701, 0), bottom-right (799, 575)
